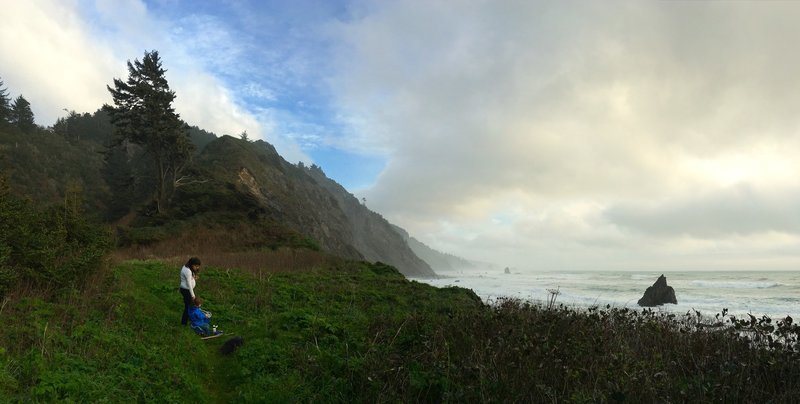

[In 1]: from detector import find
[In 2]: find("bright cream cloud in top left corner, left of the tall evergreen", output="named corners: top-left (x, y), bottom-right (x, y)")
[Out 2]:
top-left (0, 1), bottom-right (125, 125)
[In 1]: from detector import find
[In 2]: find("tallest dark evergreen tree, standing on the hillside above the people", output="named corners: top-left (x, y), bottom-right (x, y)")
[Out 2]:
top-left (103, 51), bottom-right (193, 213)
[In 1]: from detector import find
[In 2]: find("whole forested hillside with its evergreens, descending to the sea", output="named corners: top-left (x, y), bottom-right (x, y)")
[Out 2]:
top-left (0, 51), bottom-right (434, 276)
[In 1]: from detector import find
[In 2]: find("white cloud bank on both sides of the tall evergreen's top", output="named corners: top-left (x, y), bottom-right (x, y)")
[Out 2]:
top-left (0, 0), bottom-right (292, 149)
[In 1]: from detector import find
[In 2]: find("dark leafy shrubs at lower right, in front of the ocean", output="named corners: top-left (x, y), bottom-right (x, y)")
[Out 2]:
top-left (368, 300), bottom-right (800, 402)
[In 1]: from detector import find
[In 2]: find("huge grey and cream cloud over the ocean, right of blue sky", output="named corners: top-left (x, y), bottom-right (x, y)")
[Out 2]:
top-left (335, 1), bottom-right (800, 265)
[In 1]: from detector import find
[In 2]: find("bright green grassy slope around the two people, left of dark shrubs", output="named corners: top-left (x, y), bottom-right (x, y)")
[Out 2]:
top-left (0, 261), bottom-right (477, 402)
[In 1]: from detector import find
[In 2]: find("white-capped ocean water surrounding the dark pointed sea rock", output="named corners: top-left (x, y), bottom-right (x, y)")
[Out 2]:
top-left (415, 270), bottom-right (800, 319)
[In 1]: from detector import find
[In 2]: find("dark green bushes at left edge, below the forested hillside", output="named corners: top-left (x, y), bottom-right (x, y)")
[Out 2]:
top-left (0, 177), bottom-right (110, 297)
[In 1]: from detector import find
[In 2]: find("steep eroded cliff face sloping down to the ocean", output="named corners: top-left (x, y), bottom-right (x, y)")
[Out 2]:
top-left (198, 136), bottom-right (435, 277)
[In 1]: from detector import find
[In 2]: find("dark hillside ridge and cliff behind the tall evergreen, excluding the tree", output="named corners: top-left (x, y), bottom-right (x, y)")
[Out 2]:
top-left (0, 118), bottom-right (436, 277)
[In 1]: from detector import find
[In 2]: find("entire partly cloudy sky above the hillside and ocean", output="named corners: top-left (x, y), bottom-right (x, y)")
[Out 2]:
top-left (0, 0), bottom-right (800, 271)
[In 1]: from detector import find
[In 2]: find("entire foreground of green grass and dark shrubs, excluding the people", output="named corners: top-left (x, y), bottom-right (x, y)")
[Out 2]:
top-left (0, 261), bottom-right (800, 403)
